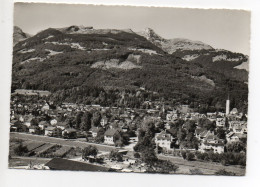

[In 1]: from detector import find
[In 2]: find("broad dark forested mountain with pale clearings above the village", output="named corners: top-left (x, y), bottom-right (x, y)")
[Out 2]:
top-left (12, 26), bottom-right (248, 112)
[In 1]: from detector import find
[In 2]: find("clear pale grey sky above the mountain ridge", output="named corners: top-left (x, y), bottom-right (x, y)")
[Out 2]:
top-left (14, 3), bottom-right (250, 55)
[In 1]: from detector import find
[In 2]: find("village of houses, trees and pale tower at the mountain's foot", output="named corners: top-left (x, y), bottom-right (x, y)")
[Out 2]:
top-left (10, 90), bottom-right (247, 173)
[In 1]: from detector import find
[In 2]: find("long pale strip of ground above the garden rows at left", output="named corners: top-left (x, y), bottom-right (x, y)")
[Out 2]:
top-left (10, 132), bottom-right (116, 152)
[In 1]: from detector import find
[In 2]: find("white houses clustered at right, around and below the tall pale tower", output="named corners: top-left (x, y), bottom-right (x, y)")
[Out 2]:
top-left (155, 104), bottom-right (247, 153)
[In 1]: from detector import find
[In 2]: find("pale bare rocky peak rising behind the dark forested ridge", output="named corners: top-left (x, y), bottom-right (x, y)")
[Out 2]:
top-left (138, 28), bottom-right (213, 54)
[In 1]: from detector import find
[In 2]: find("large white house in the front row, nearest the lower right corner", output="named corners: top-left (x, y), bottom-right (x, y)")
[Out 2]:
top-left (199, 134), bottom-right (224, 154)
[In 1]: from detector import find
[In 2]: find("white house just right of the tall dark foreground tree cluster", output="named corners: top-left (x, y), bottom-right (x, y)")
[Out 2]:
top-left (155, 131), bottom-right (173, 151)
